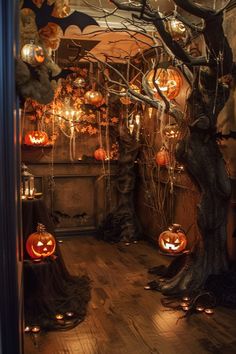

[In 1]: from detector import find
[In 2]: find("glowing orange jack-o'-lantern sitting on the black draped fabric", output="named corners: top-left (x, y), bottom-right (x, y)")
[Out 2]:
top-left (26, 224), bottom-right (56, 259)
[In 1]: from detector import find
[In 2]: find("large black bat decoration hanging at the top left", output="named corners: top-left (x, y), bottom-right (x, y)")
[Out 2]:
top-left (22, 0), bottom-right (99, 33)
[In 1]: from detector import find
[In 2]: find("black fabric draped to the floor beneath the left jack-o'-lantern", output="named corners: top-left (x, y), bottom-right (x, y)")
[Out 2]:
top-left (22, 200), bottom-right (90, 330)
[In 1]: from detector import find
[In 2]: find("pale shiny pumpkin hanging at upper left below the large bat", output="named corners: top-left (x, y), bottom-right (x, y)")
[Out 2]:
top-left (21, 43), bottom-right (45, 66)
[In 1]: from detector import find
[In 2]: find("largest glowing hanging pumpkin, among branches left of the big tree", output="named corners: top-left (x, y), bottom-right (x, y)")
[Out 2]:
top-left (147, 67), bottom-right (183, 100)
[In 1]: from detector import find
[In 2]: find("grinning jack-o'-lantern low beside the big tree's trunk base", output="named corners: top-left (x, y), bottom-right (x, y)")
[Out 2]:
top-left (158, 224), bottom-right (187, 254)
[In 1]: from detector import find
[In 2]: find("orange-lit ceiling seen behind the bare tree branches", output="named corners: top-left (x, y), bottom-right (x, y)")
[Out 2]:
top-left (62, 0), bottom-right (173, 62)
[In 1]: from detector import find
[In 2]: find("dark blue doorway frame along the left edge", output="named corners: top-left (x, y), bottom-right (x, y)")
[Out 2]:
top-left (0, 0), bottom-right (23, 354)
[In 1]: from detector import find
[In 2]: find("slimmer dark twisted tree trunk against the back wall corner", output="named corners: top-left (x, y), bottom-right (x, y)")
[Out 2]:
top-left (99, 125), bottom-right (141, 242)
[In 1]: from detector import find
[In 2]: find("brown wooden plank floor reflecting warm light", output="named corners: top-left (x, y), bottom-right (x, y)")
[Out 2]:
top-left (24, 237), bottom-right (236, 354)
